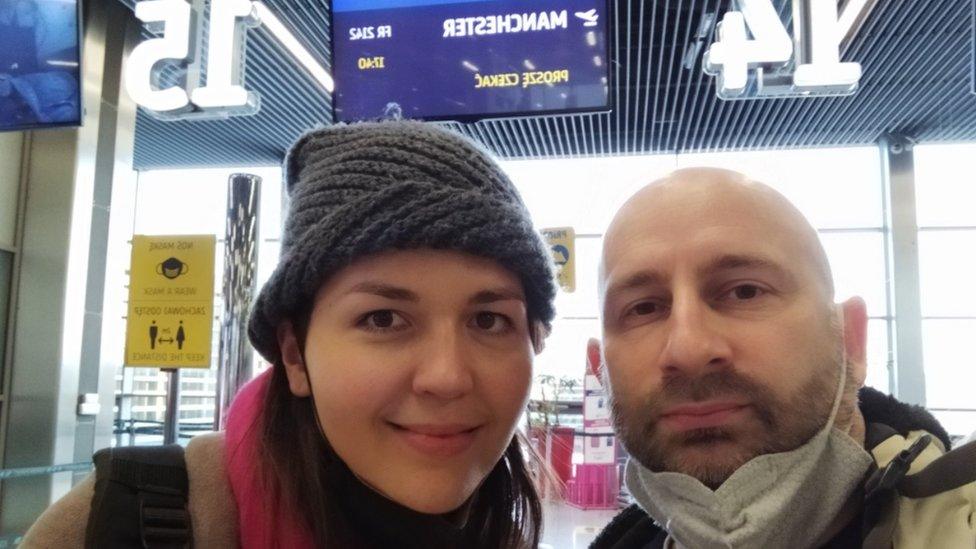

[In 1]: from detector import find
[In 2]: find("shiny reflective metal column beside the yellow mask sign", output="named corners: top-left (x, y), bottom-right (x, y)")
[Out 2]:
top-left (214, 174), bottom-right (261, 429)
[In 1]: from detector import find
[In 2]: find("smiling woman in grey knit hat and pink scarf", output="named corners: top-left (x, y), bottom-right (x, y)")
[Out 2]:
top-left (25, 122), bottom-right (555, 548)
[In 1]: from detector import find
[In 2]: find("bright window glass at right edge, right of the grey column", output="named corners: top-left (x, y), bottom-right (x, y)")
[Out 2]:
top-left (915, 145), bottom-right (976, 434)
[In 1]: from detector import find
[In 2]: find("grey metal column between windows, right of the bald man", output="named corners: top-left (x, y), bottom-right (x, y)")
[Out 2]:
top-left (879, 135), bottom-right (925, 406)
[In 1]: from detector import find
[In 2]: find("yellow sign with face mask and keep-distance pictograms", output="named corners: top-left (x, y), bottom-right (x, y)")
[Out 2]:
top-left (125, 235), bottom-right (216, 368)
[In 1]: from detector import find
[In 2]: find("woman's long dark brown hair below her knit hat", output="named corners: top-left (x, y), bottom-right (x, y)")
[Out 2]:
top-left (259, 314), bottom-right (542, 549)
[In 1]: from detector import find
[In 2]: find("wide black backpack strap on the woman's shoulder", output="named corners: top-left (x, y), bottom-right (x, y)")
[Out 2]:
top-left (85, 444), bottom-right (193, 549)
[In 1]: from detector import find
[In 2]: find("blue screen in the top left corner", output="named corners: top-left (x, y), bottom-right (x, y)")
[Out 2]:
top-left (0, 0), bottom-right (81, 131)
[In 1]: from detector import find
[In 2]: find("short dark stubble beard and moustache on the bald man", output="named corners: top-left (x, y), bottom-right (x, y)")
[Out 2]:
top-left (606, 334), bottom-right (857, 490)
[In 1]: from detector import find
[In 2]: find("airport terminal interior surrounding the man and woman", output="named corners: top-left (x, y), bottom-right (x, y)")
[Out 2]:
top-left (0, 0), bottom-right (976, 549)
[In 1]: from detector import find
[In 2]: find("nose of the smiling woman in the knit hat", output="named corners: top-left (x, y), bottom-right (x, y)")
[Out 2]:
top-left (413, 326), bottom-right (474, 400)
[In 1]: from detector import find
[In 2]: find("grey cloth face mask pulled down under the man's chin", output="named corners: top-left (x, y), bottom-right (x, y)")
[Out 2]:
top-left (625, 346), bottom-right (873, 549)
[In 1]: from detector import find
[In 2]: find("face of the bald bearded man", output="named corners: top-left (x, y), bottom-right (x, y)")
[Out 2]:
top-left (603, 180), bottom-right (853, 488)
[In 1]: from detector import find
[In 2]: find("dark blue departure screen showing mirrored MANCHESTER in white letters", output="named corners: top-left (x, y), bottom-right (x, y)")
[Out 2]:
top-left (332, 0), bottom-right (610, 122)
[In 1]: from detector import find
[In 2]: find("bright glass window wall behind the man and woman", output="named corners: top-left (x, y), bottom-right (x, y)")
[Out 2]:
top-left (118, 142), bottom-right (976, 440)
